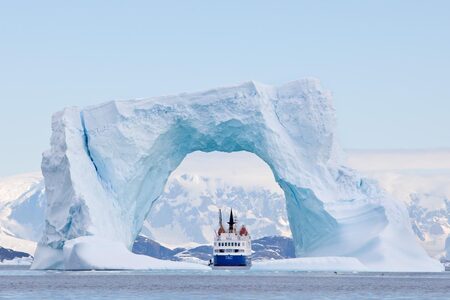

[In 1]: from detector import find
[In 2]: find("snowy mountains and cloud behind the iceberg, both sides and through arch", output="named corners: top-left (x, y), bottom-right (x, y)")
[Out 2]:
top-left (0, 151), bottom-right (450, 258)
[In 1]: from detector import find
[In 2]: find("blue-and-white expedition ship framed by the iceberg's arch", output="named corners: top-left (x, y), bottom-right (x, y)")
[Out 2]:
top-left (210, 209), bottom-right (252, 268)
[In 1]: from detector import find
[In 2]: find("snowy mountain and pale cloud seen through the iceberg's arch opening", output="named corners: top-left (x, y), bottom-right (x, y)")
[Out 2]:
top-left (140, 151), bottom-right (291, 248)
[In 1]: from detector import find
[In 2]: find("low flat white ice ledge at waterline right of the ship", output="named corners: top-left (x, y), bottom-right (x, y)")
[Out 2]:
top-left (252, 257), bottom-right (369, 272)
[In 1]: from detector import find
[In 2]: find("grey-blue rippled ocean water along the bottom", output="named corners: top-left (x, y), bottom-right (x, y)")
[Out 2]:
top-left (0, 267), bottom-right (450, 300)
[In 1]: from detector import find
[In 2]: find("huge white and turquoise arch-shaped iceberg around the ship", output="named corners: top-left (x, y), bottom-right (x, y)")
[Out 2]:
top-left (33, 80), bottom-right (437, 270)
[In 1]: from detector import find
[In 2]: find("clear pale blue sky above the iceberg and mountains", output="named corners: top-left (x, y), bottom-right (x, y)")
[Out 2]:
top-left (0, 0), bottom-right (450, 176)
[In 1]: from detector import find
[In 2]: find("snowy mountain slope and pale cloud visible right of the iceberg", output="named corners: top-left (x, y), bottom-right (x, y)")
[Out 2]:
top-left (348, 149), bottom-right (450, 259)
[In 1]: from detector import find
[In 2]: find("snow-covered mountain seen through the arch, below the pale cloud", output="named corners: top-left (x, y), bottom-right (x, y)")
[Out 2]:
top-left (141, 174), bottom-right (290, 246)
